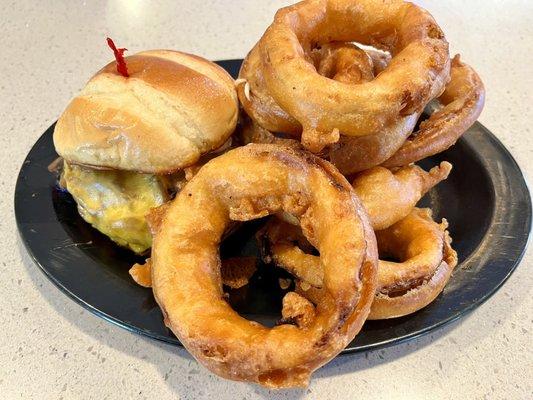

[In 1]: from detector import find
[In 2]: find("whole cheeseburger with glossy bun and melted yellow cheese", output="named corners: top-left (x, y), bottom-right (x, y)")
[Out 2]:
top-left (54, 47), bottom-right (238, 254)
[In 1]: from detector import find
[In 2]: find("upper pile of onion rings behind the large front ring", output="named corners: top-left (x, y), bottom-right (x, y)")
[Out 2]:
top-left (237, 0), bottom-right (484, 174)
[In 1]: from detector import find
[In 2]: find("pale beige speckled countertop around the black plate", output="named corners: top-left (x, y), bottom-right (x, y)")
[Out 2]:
top-left (0, 0), bottom-right (533, 399)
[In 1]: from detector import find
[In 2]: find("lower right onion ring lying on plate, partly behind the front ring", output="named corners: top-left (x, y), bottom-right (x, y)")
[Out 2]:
top-left (262, 208), bottom-right (457, 319)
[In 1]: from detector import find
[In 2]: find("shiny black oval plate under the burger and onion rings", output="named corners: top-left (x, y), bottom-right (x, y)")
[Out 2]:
top-left (15, 60), bottom-right (531, 352)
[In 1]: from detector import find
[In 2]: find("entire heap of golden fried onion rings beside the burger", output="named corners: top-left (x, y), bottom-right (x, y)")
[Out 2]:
top-left (135, 0), bottom-right (485, 388)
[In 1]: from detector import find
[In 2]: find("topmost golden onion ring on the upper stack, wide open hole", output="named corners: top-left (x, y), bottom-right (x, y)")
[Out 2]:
top-left (259, 0), bottom-right (450, 152)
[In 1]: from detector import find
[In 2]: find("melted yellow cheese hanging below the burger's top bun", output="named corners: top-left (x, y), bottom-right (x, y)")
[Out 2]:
top-left (62, 163), bottom-right (168, 253)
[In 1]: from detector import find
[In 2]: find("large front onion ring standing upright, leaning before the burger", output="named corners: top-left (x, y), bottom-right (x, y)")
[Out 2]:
top-left (152, 144), bottom-right (377, 388)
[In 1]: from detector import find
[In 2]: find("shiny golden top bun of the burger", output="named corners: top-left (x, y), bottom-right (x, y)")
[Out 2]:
top-left (54, 50), bottom-right (238, 174)
